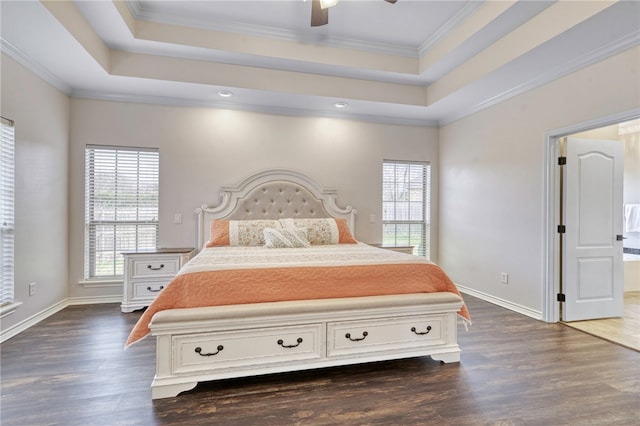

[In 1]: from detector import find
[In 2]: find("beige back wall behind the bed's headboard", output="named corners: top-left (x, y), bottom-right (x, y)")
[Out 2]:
top-left (69, 99), bottom-right (438, 297)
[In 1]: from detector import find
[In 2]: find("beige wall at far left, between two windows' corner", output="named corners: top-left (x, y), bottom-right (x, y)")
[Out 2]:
top-left (0, 54), bottom-right (69, 330)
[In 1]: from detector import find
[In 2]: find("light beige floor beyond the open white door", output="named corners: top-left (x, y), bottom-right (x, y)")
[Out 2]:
top-left (564, 291), bottom-right (640, 351)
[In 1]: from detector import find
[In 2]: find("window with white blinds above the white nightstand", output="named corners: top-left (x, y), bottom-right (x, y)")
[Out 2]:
top-left (85, 145), bottom-right (160, 279)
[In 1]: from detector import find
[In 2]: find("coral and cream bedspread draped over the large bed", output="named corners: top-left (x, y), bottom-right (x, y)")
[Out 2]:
top-left (126, 243), bottom-right (470, 346)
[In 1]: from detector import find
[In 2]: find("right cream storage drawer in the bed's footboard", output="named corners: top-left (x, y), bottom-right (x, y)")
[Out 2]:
top-left (327, 315), bottom-right (445, 357)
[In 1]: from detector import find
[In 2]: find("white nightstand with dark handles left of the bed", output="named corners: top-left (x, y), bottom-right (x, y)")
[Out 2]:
top-left (120, 247), bottom-right (195, 312)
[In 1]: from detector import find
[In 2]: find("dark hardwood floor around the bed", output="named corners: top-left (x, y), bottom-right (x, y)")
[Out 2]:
top-left (0, 296), bottom-right (640, 426)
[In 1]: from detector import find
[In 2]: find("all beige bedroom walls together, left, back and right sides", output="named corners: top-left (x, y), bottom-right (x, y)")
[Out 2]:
top-left (1, 40), bottom-right (640, 329)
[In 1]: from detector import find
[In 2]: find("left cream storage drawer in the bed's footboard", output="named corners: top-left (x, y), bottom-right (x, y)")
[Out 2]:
top-left (172, 324), bottom-right (324, 373)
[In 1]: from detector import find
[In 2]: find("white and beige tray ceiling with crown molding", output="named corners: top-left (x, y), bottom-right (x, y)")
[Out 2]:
top-left (1, 0), bottom-right (640, 125)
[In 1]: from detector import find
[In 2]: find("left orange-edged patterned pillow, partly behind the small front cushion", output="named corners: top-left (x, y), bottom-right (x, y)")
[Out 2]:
top-left (207, 219), bottom-right (282, 247)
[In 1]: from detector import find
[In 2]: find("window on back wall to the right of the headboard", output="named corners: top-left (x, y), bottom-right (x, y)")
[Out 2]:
top-left (382, 161), bottom-right (431, 258)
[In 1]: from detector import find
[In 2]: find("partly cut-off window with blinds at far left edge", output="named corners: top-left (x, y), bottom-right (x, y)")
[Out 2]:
top-left (0, 117), bottom-right (15, 306)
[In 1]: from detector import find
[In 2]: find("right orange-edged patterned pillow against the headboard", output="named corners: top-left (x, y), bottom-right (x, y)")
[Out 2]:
top-left (280, 218), bottom-right (358, 245)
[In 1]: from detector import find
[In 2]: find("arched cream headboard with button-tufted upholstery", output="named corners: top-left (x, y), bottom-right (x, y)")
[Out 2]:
top-left (195, 170), bottom-right (357, 249)
